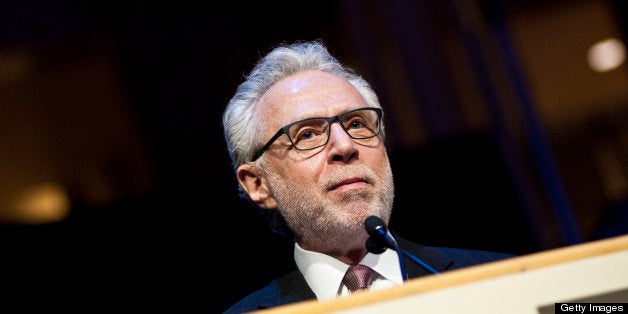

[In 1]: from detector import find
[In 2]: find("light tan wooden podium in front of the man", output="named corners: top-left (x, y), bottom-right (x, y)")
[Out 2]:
top-left (255, 235), bottom-right (628, 314)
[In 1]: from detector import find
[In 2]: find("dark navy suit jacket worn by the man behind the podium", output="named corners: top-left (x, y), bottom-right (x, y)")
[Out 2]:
top-left (224, 235), bottom-right (513, 314)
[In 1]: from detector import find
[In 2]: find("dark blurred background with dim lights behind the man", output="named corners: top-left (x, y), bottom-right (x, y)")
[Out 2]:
top-left (0, 0), bottom-right (628, 312)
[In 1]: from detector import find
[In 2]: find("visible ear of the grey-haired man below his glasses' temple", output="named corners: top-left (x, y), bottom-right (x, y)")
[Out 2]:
top-left (236, 164), bottom-right (277, 208)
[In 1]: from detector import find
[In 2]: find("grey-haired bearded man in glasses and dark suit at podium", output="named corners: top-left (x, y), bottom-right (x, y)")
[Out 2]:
top-left (223, 41), bottom-right (510, 313)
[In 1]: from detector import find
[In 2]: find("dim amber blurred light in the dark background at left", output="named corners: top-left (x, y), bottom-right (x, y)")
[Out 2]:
top-left (15, 183), bottom-right (70, 224)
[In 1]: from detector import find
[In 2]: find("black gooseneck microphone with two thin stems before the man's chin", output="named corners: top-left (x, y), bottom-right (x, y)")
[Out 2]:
top-left (364, 216), bottom-right (438, 281)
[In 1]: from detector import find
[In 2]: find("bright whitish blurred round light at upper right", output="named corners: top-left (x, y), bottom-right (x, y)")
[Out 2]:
top-left (587, 38), bottom-right (626, 72)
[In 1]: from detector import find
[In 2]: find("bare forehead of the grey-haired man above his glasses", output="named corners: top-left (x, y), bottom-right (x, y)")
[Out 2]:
top-left (255, 71), bottom-right (367, 129)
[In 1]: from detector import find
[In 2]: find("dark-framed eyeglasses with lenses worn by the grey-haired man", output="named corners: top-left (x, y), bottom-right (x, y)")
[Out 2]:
top-left (251, 107), bottom-right (382, 161)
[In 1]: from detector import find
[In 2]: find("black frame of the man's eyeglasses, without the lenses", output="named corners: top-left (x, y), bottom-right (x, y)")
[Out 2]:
top-left (251, 107), bottom-right (383, 162)
